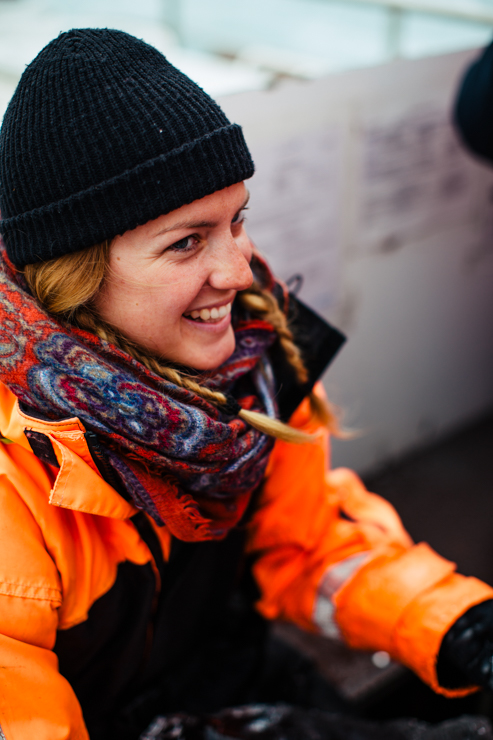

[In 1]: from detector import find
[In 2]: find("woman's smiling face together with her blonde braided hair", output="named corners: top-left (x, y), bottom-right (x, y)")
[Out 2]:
top-left (24, 183), bottom-right (316, 442)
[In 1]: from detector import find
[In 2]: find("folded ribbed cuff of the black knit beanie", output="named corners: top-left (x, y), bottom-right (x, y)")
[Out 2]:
top-left (0, 124), bottom-right (254, 267)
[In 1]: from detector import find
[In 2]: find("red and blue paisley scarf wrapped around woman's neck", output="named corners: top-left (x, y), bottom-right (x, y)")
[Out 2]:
top-left (0, 243), bottom-right (276, 541)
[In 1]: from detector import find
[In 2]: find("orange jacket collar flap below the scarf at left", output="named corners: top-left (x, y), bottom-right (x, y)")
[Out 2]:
top-left (0, 383), bottom-right (137, 519)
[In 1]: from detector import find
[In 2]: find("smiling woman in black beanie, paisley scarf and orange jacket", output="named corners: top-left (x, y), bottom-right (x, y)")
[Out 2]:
top-left (0, 29), bottom-right (493, 740)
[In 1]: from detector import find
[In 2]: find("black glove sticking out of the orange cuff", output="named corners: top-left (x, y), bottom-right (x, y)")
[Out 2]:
top-left (437, 600), bottom-right (493, 688)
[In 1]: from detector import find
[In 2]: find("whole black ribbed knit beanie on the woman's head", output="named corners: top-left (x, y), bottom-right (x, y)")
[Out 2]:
top-left (0, 28), bottom-right (253, 267)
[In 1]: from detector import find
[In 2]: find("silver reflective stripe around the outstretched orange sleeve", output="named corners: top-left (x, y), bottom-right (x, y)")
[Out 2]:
top-left (313, 552), bottom-right (370, 640)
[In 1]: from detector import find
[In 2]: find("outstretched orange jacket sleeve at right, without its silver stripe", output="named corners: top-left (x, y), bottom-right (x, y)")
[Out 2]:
top-left (248, 390), bottom-right (493, 696)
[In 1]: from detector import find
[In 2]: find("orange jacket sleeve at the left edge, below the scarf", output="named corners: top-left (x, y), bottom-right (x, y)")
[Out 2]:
top-left (0, 475), bottom-right (89, 740)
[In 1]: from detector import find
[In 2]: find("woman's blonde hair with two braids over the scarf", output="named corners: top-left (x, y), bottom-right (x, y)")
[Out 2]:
top-left (24, 241), bottom-right (337, 443)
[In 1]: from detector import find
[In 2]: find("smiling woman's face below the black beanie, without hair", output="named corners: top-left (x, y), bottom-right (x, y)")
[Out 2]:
top-left (95, 183), bottom-right (253, 370)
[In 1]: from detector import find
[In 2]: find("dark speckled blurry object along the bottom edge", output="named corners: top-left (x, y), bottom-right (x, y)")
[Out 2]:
top-left (140, 704), bottom-right (493, 740)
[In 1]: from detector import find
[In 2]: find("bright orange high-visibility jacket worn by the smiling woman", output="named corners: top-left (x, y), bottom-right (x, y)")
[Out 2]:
top-left (0, 385), bottom-right (493, 740)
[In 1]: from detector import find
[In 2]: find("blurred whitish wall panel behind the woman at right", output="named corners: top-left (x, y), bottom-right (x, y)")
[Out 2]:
top-left (217, 47), bottom-right (493, 472)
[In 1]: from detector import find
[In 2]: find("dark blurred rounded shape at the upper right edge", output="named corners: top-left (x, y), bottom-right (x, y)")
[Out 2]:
top-left (454, 43), bottom-right (493, 162)
